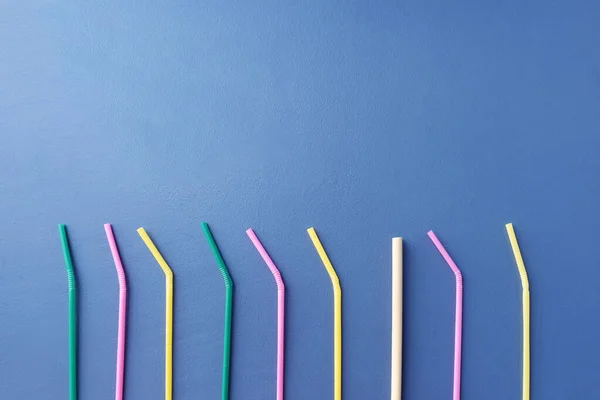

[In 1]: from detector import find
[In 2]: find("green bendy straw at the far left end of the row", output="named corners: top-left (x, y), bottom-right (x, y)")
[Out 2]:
top-left (58, 224), bottom-right (77, 400)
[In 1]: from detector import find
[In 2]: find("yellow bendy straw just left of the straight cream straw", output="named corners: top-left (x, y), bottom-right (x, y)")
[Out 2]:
top-left (308, 228), bottom-right (342, 400)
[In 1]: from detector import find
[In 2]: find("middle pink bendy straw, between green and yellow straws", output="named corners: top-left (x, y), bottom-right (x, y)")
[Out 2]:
top-left (246, 228), bottom-right (285, 400)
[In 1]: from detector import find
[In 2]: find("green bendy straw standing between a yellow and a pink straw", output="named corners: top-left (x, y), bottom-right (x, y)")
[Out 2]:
top-left (202, 222), bottom-right (233, 400)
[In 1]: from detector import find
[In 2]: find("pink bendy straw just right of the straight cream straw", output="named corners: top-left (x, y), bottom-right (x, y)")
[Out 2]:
top-left (427, 231), bottom-right (463, 400)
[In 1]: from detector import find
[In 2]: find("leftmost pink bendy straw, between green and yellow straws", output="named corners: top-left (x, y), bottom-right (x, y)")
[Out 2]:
top-left (104, 224), bottom-right (127, 400)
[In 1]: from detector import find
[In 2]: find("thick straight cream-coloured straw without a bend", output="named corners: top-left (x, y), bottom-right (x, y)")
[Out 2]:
top-left (391, 237), bottom-right (402, 400)
